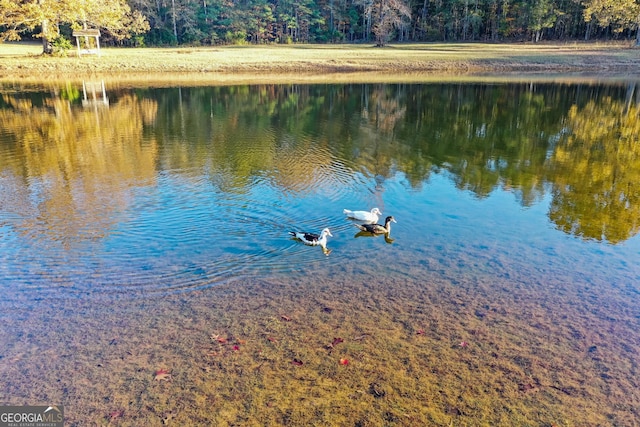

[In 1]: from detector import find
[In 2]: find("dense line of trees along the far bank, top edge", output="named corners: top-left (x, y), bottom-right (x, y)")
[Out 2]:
top-left (0, 0), bottom-right (640, 51)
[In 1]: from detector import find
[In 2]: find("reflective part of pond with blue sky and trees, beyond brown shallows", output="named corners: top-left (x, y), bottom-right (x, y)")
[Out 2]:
top-left (0, 84), bottom-right (640, 299)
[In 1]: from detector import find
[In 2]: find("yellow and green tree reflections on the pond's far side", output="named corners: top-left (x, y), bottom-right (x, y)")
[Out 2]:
top-left (0, 83), bottom-right (640, 244)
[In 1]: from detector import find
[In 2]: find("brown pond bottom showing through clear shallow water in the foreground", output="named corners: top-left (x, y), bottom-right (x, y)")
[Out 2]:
top-left (0, 262), bottom-right (640, 426)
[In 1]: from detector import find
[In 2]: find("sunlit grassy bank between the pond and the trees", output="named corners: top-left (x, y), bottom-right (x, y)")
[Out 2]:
top-left (0, 43), bottom-right (640, 81)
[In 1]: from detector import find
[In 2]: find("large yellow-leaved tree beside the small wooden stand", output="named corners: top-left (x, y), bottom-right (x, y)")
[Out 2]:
top-left (0, 0), bottom-right (149, 53)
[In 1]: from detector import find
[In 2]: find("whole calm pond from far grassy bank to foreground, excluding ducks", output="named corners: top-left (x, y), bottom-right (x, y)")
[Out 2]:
top-left (0, 81), bottom-right (640, 426)
